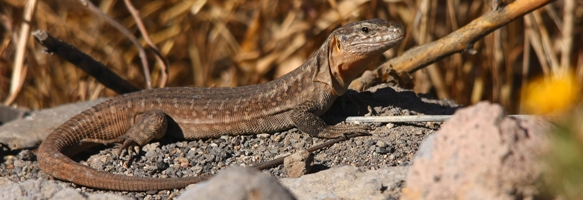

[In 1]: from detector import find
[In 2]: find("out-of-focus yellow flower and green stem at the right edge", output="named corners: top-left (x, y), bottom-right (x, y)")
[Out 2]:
top-left (522, 73), bottom-right (583, 200)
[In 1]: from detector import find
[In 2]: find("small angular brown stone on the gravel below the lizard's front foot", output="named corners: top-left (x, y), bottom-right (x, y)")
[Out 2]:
top-left (283, 150), bottom-right (314, 178)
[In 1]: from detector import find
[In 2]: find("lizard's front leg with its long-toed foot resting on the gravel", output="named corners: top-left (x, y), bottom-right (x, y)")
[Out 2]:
top-left (290, 101), bottom-right (370, 138)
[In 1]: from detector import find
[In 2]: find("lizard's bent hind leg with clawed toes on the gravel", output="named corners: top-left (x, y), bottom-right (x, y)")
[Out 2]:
top-left (81, 110), bottom-right (168, 157)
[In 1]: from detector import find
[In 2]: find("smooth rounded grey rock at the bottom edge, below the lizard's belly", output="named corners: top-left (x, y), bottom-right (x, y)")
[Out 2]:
top-left (177, 167), bottom-right (295, 200)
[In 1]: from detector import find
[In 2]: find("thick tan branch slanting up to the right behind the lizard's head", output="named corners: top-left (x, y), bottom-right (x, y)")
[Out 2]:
top-left (353, 0), bottom-right (556, 91)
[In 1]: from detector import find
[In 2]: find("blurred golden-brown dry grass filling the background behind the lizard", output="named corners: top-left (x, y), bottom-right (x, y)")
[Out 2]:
top-left (0, 0), bottom-right (583, 113)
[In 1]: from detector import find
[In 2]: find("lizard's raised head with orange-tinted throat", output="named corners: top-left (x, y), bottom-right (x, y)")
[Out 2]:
top-left (328, 19), bottom-right (405, 95)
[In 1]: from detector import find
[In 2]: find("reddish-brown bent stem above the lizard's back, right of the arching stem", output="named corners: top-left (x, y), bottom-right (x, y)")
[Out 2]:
top-left (124, 0), bottom-right (168, 88)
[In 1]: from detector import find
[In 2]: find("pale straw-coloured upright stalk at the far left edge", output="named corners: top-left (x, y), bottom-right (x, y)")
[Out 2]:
top-left (4, 0), bottom-right (37, 105)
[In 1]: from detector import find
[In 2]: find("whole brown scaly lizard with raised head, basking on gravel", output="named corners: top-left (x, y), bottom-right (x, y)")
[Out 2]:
top-left (37, 19), bottom-right (405, 191)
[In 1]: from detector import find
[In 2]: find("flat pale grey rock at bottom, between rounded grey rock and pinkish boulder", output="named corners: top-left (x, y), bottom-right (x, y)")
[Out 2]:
top-left (279, 166), bottom-right (409, 200)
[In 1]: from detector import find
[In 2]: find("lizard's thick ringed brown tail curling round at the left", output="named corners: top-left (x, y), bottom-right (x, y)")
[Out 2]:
top-left (37, 109), bottom-right (209, 191)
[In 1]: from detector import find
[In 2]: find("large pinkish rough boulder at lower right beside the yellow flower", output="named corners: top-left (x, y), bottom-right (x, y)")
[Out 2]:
top-left (402, 103), bottom-right (550, 199)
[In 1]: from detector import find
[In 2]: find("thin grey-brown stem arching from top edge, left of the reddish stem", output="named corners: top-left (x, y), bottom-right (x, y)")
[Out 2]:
top-left (79, 0), bottom-right (152, 89)
